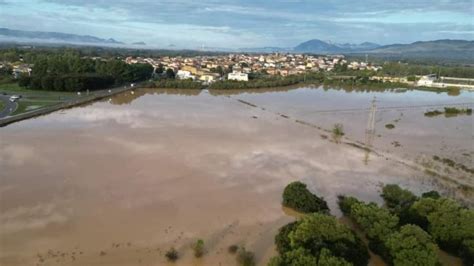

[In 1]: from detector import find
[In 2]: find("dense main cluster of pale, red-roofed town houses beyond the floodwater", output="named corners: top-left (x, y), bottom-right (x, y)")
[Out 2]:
top-left (125, 53), bottom-right (381, 83)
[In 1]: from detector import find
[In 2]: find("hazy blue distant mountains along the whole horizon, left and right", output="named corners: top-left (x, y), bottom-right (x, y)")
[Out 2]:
top-left (0, 28), bottom-right (474, 62)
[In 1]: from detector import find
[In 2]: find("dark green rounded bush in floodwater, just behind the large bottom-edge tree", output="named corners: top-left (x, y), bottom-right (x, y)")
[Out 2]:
top-left (283, 181), bottom-right (329, 213)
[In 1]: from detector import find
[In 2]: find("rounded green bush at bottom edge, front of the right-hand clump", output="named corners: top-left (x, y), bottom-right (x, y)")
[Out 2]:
top-left (385, 225), bottom-right (439, 266)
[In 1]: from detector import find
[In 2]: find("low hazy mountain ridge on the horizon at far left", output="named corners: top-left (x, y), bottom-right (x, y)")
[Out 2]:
top-left (0, 28), bottom-right (124, 45)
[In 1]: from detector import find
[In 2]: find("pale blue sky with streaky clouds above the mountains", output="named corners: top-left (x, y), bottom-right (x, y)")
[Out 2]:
top-left (0, 0), bottom-right (474, 48)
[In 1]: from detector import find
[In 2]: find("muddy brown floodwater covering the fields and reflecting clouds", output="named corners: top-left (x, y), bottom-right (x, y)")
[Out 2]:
top-left (0, 88), bottom-right (474, 265)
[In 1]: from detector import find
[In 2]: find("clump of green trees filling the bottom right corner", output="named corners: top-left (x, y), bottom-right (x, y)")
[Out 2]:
top-left (339, 185), bottom-right (474, 265)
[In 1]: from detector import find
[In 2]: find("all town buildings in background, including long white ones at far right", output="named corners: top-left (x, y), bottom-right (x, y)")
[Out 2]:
top-left (0, 53), bottom-right (474, 90)
